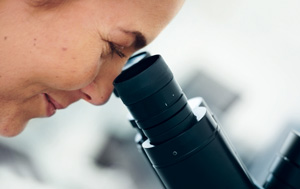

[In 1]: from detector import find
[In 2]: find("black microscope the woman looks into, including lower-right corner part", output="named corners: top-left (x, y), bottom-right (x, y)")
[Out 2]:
top-left (114, 52), bottom-right (300, 189)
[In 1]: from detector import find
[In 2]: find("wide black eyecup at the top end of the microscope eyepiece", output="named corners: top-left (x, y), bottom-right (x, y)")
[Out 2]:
top-left (114, 55), bottom-right (173, 105)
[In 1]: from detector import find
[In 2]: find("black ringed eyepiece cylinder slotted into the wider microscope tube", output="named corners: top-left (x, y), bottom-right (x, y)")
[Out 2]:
top-left (114, 55), bottom-right (197, 144)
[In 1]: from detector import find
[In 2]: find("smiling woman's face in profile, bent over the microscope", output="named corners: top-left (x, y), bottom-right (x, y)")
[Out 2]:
top-left (0, 0), bottom-right (182, 136)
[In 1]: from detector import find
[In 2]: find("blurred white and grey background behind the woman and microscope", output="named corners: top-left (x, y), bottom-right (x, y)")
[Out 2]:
top-left (0, 0), bottom-right (300, 189)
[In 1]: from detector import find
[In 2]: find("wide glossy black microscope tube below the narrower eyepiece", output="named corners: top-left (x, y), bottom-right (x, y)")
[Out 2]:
top-left (142, 98), bottom-right (257, 189)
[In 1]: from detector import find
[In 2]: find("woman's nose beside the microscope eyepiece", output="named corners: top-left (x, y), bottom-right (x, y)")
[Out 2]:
top-left (80, 59), bottom-right (126, 105)
